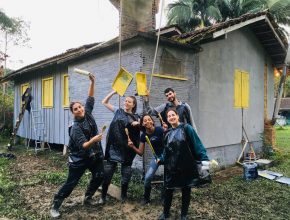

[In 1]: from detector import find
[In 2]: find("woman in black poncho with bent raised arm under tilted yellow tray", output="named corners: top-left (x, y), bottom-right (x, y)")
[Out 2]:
top-left (99, 91), bottom-right (140, 203)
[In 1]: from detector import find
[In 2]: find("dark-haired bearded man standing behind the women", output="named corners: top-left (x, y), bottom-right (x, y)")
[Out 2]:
top-left (145, 88), bottom-right (197, 132)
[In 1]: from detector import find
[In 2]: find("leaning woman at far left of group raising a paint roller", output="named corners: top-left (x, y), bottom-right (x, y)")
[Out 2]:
top-left (50, 75), bottom-right (104, 217)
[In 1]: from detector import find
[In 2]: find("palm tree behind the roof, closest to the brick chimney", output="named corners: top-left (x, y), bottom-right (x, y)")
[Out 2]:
top-left (167, 0), bottom-right (222, 31)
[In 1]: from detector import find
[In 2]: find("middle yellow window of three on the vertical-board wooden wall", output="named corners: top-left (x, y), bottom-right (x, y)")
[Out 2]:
top-left (42, 77), bottom-right (53, 108)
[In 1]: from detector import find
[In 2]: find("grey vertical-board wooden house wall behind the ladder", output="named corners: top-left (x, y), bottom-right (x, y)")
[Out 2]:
top-left (14, 65), bottom-right (71, 144)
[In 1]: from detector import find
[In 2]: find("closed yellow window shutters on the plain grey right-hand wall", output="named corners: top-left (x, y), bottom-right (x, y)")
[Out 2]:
top-left (234, 69), bottom-right (250, 108)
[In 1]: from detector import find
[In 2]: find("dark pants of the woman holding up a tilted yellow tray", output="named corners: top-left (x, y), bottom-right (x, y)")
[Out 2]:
top-left (102, 161), bottom-right (132, 198)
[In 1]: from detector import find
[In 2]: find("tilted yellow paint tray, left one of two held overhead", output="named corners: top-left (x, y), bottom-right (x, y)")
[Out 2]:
top-left (112, 67), bottom-right (133, 96)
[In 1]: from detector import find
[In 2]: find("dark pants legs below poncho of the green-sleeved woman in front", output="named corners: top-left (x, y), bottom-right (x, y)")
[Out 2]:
top-left (163, 187), bottom-right (191, 217)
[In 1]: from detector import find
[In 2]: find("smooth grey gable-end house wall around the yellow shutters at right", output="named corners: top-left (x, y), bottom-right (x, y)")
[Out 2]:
top-left (199, 28), bottom-right (274, 164)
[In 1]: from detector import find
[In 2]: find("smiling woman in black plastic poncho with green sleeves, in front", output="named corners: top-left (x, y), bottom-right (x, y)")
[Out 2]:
top-left (158, 109), bottom-right (209, 219)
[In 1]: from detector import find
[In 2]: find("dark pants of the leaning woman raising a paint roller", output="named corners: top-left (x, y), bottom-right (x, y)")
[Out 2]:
top-left (54, 159), bottom-right (104, 201)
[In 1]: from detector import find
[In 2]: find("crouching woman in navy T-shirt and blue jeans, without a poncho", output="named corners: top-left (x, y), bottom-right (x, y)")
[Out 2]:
top-left (128, 114), bottom-right (164, 205)
